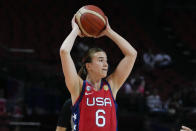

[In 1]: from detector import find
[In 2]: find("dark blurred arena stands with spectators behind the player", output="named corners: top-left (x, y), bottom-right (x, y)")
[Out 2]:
top-left (0, 0), bottom-right (196, 131)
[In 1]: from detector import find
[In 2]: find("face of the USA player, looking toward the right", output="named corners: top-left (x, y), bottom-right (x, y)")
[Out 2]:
top-left (89, 52), bottom-right (108, 78)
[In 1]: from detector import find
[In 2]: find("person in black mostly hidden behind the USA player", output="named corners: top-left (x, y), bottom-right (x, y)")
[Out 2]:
top-left (56, 99), bottom-right (73, 131)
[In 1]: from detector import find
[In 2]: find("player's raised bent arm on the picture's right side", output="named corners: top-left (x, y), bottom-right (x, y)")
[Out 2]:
top-left (104, 20), bottom-right (137, 98)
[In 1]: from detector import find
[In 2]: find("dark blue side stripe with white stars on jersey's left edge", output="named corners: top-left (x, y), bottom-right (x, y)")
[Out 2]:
top-left (72, 81), bottom-right (86, 131)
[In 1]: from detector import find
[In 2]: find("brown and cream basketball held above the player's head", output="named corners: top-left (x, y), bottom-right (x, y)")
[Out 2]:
top-left (75, 5), bottom-right (107, 37)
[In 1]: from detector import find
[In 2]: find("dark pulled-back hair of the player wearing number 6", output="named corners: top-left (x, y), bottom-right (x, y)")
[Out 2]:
top-left (78, 48), bottom-right (105, 80)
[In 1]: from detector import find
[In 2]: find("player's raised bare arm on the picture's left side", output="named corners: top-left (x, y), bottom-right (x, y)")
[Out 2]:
top-left (60, 17), bottom-right (83, 103)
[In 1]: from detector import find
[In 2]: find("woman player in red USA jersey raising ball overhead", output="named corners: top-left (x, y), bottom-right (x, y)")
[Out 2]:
top-left (60, 16), bottom-right (137, 131)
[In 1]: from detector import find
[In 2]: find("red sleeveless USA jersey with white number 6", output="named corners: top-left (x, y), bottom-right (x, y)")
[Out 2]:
top-left (72, 80), bottom-right (117, 131)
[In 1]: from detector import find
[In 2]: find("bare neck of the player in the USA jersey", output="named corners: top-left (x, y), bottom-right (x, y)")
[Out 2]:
top-left (86, 74), bottom-right (101, 90)
